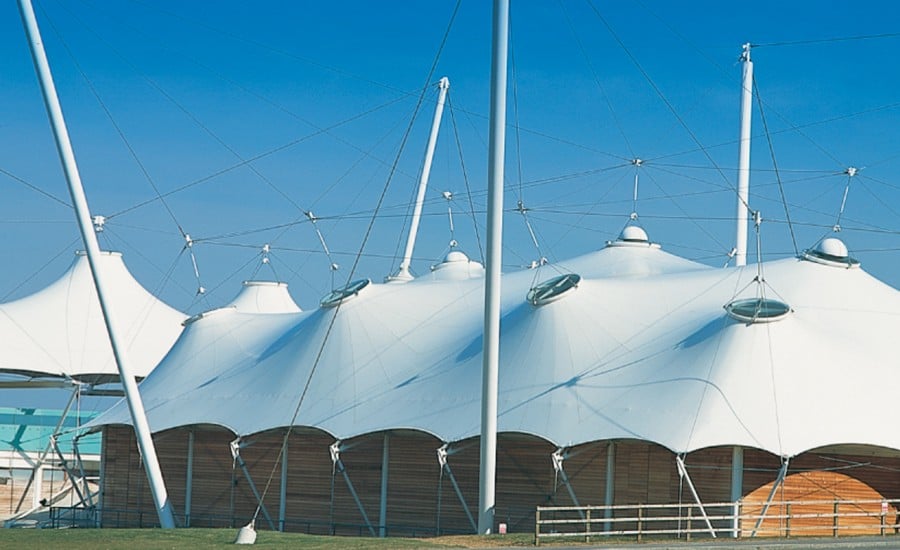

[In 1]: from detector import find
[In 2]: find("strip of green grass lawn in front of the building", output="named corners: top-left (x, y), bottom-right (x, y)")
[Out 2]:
top-left (0, 529), bottom-right (533, 550)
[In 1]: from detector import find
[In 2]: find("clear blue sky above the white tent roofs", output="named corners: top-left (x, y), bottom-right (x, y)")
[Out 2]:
top-left (0, 0), bottom-right (900, 324)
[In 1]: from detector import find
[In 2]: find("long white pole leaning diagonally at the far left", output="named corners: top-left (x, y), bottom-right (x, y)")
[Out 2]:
top-left (19, 0), bottom-right (175, 529)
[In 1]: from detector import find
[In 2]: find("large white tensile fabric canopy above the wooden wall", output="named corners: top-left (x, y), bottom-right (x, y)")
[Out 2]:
top-left (89, 235), bottom-right (900, 456)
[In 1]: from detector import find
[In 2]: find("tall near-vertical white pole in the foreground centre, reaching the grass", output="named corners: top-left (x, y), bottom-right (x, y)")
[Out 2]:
top-left (478, 0), bottom-right (509, 535)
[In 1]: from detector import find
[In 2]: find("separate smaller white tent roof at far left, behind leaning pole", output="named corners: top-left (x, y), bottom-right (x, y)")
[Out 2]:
top-left (0, 252), bottom-right (186, 382)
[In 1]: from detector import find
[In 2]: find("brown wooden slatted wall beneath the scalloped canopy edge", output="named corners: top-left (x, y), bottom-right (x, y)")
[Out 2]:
top-left (102, 426), bottom-right (900, 535)
